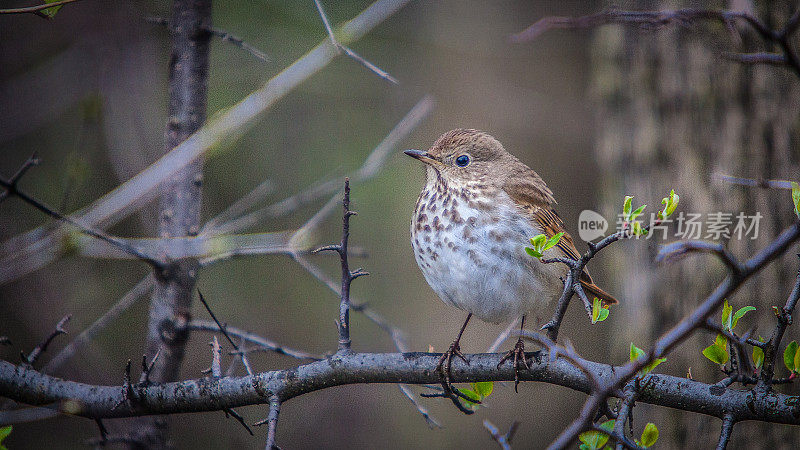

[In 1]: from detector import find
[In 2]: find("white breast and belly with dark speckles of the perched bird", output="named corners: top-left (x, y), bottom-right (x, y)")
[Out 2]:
top-left (411, 184), bottom-right (566, 323)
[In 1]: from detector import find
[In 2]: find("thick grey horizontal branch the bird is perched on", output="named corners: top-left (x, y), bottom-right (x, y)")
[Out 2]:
top-left (0, 353), bottom-right (800, 425)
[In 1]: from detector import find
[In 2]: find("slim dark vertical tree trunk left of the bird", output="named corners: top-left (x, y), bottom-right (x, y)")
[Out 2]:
top-left (133, 0), bottom-right (211, 447)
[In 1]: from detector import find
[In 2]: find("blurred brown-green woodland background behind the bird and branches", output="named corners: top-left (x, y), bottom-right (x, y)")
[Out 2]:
top-left (0, 0), bottom-right (800, 448)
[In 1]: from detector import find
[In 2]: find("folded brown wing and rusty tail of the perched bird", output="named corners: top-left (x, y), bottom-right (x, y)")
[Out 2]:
top-left (504, 181), bottom-right (619, 305)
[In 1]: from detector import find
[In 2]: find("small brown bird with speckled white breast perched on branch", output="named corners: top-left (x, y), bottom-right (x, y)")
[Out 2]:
top-left (405, 129), bottom-right (617, 386)
